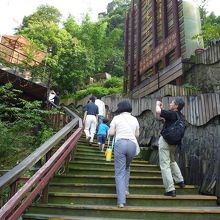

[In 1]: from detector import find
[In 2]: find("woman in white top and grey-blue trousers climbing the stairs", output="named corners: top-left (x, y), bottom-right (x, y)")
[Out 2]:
top-left (109, 101), bottom-right (140, 208)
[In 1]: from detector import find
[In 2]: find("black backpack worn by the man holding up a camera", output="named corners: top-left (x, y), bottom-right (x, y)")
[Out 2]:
top-left (161, 112), bottom-right (185, 145)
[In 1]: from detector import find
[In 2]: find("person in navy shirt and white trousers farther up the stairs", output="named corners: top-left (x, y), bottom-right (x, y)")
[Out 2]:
top-left (83, 96), bottom-right (99, 144)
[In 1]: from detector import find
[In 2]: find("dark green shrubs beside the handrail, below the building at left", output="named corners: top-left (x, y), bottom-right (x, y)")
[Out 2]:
top-left (0, 84), bottom-right (55, 160)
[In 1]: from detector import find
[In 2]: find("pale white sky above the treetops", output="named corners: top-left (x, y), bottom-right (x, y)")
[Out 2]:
top-left (0, 0), bottom-right (220, 35)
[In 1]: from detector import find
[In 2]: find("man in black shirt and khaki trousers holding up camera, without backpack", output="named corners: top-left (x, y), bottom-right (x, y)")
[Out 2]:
top-left (156, 98), bottom-right (185, 197)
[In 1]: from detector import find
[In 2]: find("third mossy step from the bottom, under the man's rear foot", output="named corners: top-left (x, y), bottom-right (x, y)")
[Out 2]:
top-left (49, 182), bottom-right (198, 195)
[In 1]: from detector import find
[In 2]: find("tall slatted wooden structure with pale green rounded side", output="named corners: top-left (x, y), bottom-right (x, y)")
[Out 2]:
top-left (124, 0), bottom-right (203, 98)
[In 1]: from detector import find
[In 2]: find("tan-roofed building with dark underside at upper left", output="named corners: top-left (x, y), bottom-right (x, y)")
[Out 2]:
top-left (0, 35), bottom-right (48, 101)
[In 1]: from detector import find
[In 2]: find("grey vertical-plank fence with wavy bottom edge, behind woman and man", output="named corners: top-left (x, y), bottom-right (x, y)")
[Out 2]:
top-left (102, 93), bottom-right (220, 126)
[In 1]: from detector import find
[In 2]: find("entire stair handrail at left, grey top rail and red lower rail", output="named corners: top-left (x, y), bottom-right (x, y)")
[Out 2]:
top-left (0, 104), bottom-right (82, 220)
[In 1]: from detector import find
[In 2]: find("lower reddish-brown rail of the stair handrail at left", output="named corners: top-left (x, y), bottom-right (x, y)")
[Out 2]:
top-left (0, 128), bottom-right (81, 219)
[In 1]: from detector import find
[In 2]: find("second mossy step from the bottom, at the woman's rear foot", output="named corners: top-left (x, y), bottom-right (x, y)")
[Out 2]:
top-left (49, 192), bottom-right (217, 207)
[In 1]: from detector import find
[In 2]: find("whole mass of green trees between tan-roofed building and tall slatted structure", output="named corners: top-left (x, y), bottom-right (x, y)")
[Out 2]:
top-left (17, 0), bottom-right (130, 95)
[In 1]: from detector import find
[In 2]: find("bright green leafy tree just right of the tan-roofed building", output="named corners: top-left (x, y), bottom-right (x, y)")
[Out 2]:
top-left (18, 6), bottom-right (87, 93)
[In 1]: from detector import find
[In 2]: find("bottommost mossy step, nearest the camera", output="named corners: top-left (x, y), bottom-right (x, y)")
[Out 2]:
top-left (25, 203), bottom-right (220, 220)
